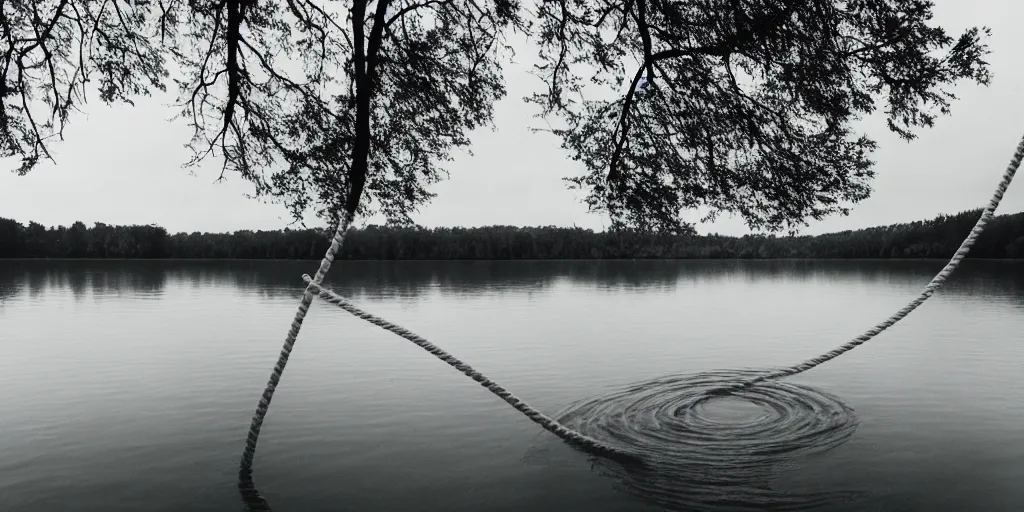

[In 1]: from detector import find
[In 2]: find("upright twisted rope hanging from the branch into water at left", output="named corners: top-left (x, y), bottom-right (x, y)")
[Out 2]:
top-left (239, 212), bottom-right (353, 510)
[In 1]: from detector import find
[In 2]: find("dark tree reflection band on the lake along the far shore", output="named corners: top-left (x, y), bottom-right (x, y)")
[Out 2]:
top-left (0, 260), bottom-right (1024, 300)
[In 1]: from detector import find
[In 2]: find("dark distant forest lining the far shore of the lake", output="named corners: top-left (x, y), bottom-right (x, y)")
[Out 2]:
top-left (0, 210), bottom-right (1024, 260)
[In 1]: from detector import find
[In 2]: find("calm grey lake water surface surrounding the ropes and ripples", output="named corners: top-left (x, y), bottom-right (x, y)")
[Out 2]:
top-left (0, 261), bottom-right (1024, 512)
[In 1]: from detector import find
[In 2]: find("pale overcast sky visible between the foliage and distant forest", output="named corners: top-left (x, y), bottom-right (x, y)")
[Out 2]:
top-left (0, 0), bottom-right (1024, 234)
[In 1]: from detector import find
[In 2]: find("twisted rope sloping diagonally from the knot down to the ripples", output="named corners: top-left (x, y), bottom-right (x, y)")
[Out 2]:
top-left (302, 274), bottom-right (636, 460)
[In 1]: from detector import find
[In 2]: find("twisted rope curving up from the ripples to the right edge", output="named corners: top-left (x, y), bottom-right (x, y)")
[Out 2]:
top-left (714, 134), bottom-right (1024, 393)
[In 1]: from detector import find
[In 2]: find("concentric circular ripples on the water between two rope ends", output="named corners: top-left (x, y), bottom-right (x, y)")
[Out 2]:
top-left (558, 371), bottom-right (857, 511)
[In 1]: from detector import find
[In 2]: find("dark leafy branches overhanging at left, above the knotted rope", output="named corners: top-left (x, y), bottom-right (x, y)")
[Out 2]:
top-left (0, 0), bottom-right (522, 223)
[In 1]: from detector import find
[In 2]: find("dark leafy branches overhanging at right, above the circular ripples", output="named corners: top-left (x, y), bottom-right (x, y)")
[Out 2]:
top-left (532, 0), bottom-right (989, 232)
